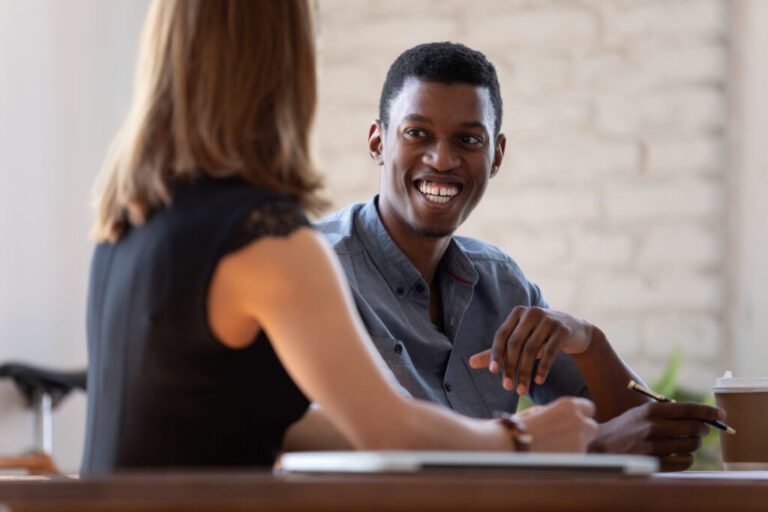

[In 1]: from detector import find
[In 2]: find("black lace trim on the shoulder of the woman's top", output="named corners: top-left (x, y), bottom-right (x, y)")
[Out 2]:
top-left (226, 199), bottom-right (311, 252)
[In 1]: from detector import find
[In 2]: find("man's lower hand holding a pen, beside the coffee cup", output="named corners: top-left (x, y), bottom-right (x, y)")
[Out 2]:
top-left (589, 402), bottom-right (725, 471)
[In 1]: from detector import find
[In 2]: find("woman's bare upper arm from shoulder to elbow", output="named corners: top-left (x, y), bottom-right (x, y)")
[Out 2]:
top-left (220, 228), bottom-right (404, 444)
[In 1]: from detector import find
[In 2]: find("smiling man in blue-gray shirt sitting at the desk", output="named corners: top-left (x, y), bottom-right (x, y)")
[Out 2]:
top-left (318, 43), bottom-right (721, 470)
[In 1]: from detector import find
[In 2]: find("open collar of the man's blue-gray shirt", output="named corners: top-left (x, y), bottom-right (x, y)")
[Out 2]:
top-left (355, 195), bottom-right (479, 296)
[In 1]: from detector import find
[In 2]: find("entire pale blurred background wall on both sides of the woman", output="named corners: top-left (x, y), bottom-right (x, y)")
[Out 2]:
top-left (0, 0), bottom-right (768, 470)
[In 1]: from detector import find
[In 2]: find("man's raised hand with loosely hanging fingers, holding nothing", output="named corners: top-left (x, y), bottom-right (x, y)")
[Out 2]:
top-left (469, 306), bottom-right (594, 396)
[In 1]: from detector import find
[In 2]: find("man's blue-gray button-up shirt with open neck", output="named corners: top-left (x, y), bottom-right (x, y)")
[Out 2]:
top-left (316, 197), bottom-right (589, 418)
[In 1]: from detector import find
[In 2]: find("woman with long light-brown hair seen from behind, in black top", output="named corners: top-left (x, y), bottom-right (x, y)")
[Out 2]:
top-left (83, 0), bottom-right (596, 474)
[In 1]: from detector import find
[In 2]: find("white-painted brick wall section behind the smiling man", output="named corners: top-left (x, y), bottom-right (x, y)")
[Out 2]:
top-left (318, 0), bottom-right (728, 390)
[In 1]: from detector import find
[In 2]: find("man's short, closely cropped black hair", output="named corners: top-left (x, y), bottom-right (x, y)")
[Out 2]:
top-left (379, 42), bottom-right (501, 135)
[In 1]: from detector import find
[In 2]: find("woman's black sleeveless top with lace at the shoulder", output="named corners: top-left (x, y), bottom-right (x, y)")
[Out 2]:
top-left (82, 178), bottom-right (309, 474)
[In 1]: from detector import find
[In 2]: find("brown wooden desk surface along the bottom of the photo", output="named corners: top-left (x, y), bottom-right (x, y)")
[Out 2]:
top-left (0, 471), bottom-right (768, 512)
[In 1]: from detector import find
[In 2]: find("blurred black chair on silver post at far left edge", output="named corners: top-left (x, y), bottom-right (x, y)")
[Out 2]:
top-left (0, 363), bottom-right (86, 475)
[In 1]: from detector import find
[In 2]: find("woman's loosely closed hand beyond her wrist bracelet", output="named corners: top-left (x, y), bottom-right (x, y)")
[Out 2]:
top-left (516, 397), bottom-right (597, 452)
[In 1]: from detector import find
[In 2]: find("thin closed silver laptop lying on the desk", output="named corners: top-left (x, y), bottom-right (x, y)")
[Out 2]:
top-left (276, 451), bottom-right (659, 475)
